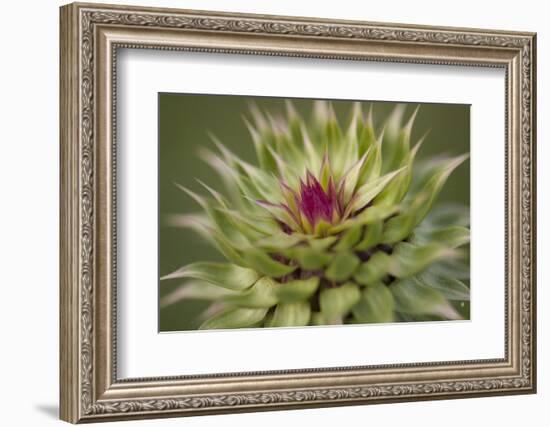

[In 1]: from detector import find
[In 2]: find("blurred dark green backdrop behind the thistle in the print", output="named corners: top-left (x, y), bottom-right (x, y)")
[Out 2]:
top-left (158, 93), bottom-right (470, 332)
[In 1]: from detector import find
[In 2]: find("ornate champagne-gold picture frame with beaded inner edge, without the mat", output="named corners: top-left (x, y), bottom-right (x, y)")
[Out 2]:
top-left (60, 4), bottom-right (536, 423)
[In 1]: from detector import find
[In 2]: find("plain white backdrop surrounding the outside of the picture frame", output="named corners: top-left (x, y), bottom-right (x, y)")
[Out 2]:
top-left (0, 0), bottom-right (550, 427)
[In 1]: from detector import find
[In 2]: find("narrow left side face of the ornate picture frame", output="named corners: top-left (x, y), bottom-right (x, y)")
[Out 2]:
top-left (59, 5), bottom-right (80, 423)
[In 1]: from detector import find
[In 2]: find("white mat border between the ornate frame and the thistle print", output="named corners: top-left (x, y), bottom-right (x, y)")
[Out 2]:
top-left (117, 50), bottom-right (505, 378)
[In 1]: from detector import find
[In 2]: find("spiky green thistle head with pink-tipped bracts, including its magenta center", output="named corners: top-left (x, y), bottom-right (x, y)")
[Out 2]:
top-left (163, 101), bottom-right (470, 329)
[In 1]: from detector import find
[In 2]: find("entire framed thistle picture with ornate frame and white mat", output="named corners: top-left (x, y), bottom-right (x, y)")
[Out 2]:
top-left (60, 4), bottom-right (536, 423)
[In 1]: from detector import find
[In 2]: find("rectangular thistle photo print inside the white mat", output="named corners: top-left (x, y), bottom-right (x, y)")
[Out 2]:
top-left (158, 93), bottom-right (470, 332)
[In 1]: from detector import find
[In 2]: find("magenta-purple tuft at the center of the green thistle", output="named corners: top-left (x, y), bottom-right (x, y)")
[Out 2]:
top-left (298, 173), bottom-right (337, 226)
